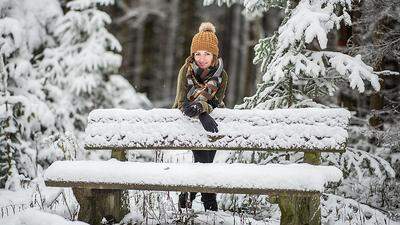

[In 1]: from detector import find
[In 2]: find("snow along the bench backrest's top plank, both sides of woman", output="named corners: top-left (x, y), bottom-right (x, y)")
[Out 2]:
top-left (88, 108), bottom-right (351, 127)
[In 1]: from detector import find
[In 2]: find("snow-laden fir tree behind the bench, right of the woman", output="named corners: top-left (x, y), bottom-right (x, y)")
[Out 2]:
top-left (206, 0), bottom-right (380, 109)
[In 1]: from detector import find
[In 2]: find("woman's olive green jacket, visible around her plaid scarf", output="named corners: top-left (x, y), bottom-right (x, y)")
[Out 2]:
top-left (172, 63), bottom-right (228, 113)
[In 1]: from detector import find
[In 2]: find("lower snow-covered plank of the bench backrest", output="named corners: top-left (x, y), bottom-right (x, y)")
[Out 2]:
top-left (85, 122), bottom-right (348, 151)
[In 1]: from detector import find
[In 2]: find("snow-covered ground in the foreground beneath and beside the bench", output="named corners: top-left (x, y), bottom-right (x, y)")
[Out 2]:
top-left (0, 188), bottom-right (400, 225)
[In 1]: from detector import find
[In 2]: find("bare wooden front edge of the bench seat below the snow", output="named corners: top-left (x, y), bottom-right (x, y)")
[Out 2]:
top-left (45, 180), bottom-right (319, 196)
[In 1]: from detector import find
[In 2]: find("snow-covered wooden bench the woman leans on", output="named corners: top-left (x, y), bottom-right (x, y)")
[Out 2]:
top-left (45, 108), bottom-right (350, 224)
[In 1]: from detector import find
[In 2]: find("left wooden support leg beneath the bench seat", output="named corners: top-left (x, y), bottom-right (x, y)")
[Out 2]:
top-left (73, 188), bottom-right (129, 224)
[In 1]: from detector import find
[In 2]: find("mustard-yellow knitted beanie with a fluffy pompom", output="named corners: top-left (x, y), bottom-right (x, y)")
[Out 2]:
top-left (190, 22), bottom-right (219, 57)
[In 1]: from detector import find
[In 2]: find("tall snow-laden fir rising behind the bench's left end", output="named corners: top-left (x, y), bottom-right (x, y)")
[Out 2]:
top-left (42, 0), bottom-right (121, 131)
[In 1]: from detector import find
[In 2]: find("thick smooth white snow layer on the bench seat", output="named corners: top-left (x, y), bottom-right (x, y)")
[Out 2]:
top-left (44, 159), bottom-right (342, 192)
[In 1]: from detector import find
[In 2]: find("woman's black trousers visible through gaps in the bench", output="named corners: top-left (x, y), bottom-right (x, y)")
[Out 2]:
top-left (190, 150), bottom-right (217, 209)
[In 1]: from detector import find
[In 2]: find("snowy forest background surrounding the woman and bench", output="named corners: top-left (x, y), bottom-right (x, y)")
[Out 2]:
top-left (0, 0), bottom-right (400, 224)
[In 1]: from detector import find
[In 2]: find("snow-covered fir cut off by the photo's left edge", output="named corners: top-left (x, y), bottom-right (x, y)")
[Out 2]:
top-left (0, 1), bottom-right (58, 190)
